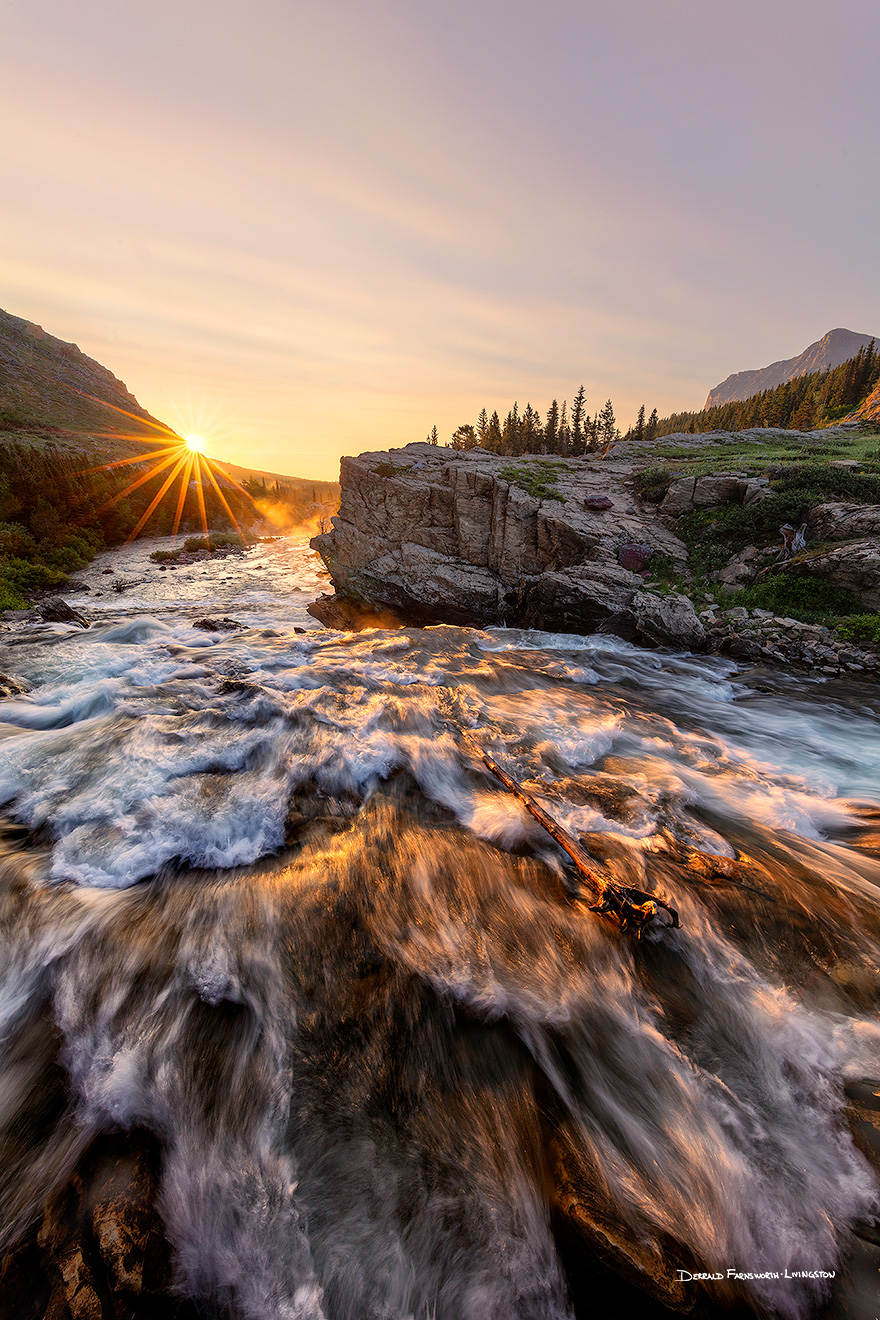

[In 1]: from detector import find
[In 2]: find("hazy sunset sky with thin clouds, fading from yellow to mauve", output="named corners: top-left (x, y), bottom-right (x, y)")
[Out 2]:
top-left (0, 0), bottom-right (880, 478)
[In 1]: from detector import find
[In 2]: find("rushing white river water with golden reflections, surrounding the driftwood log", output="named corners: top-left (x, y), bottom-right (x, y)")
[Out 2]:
top-left (0, 543), bottom-right (880, 1320)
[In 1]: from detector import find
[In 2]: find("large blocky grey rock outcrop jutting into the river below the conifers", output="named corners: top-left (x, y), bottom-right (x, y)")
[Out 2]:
top-left (311, 444), bottom-right (705, 648)
